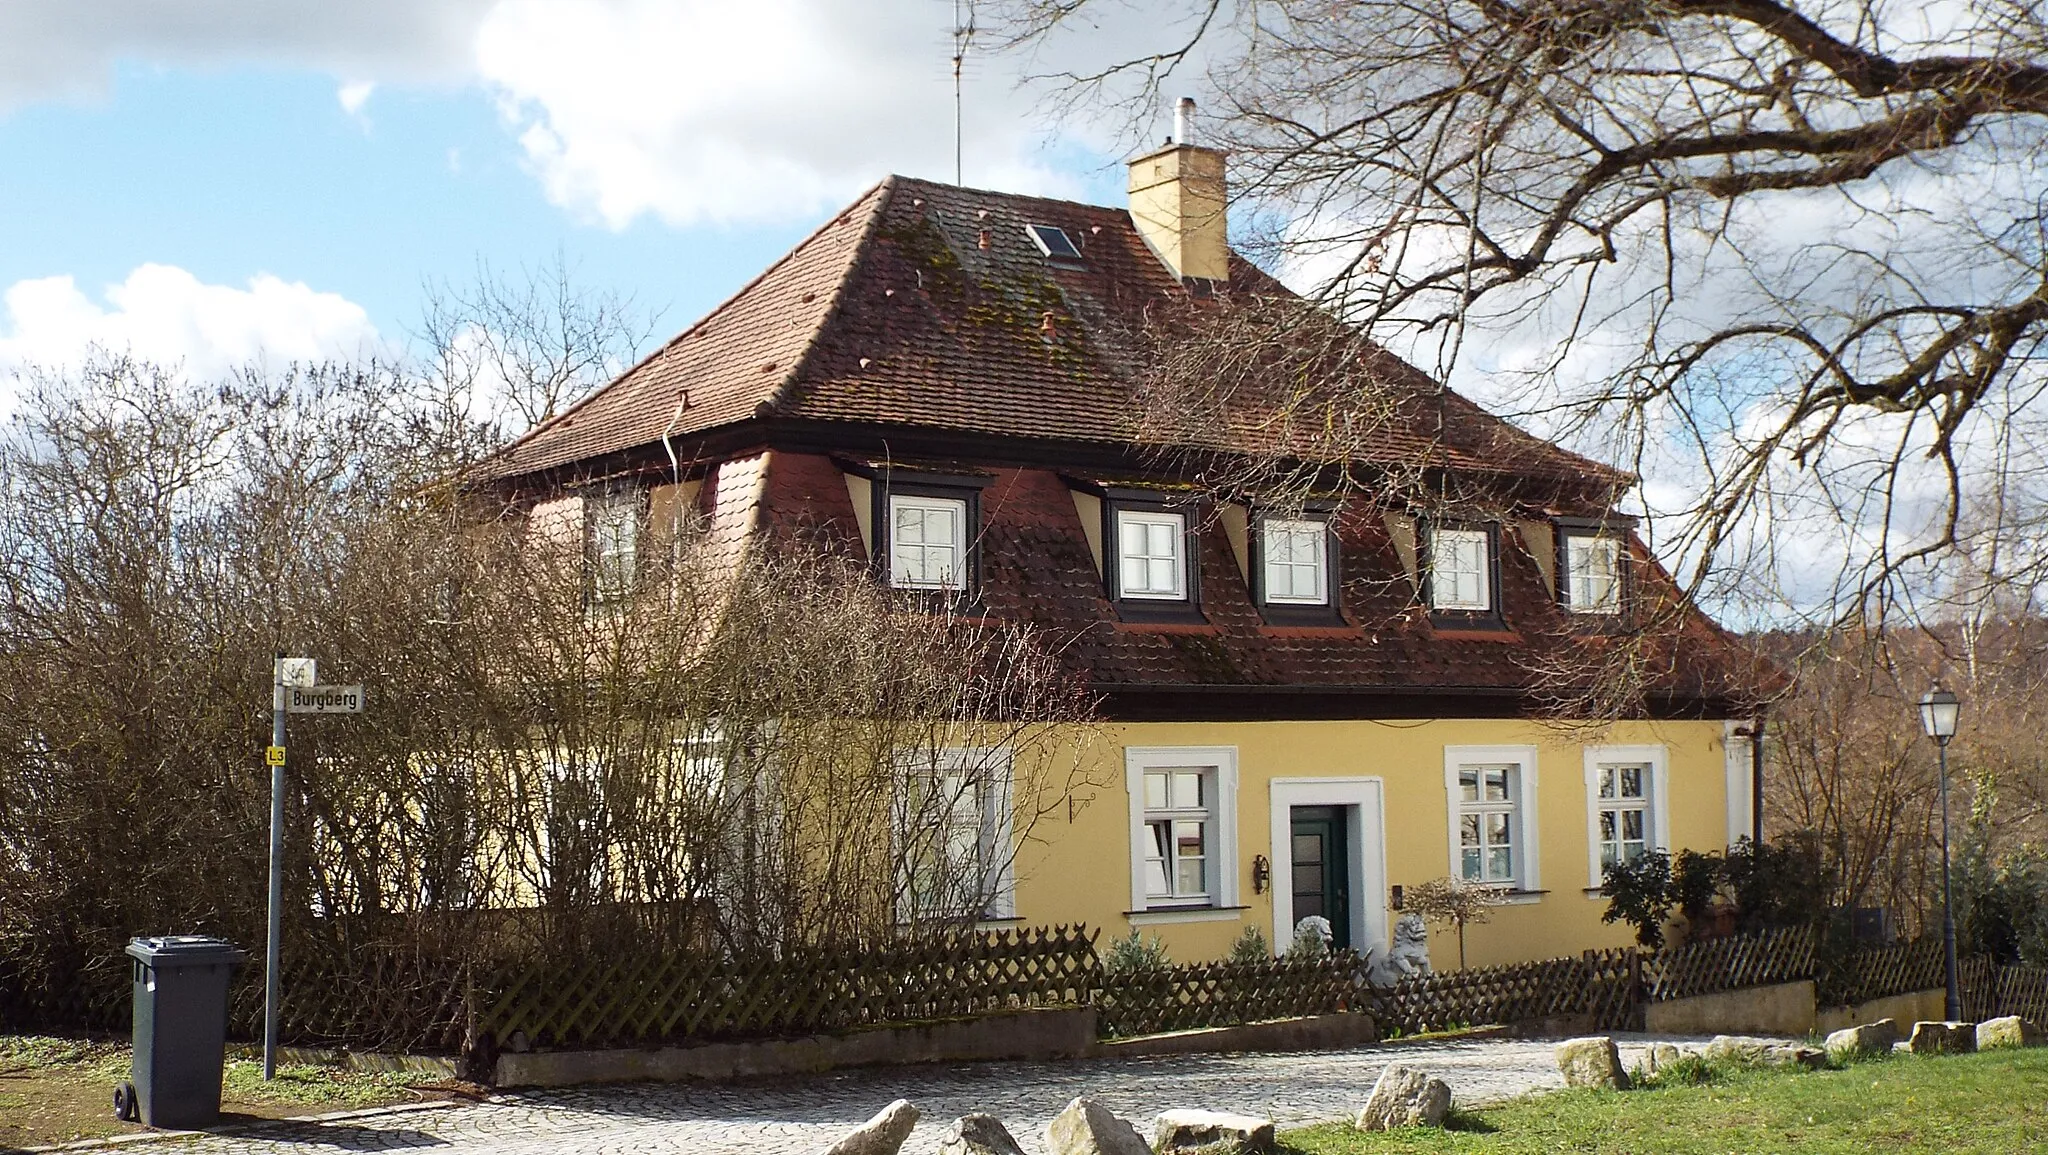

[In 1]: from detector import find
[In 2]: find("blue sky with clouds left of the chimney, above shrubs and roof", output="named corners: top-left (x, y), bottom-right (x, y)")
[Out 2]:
top-left (0, 0), bottom-right (1122, 385)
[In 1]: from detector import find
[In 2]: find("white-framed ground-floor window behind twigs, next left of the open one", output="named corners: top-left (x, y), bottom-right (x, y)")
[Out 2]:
top-left (899, 747), bottom-right (1016, 922)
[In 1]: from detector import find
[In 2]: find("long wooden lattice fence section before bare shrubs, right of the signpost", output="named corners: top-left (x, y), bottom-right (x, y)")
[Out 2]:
top-left (473, 926), bottom-right (1098, 1049)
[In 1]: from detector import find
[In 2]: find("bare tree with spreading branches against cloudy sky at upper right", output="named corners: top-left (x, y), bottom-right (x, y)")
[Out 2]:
top-left (999, 0), bottom-right (2048, 612)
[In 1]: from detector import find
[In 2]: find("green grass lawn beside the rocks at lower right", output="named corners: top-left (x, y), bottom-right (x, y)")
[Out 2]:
top-left (1282, 1049), bottom-right (2048, 1155)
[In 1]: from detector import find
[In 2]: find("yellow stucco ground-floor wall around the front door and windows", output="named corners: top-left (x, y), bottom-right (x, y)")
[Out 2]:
top-left (1016, 719), bottom-right (1729, 969)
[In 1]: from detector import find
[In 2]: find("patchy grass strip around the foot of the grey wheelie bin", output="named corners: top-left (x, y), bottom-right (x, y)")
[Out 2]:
top-left (0, 1034), bottom-right (462, 1151)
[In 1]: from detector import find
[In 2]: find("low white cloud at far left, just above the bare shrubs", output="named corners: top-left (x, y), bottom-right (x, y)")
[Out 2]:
top-left (0, 264), bottom-right (377, 377)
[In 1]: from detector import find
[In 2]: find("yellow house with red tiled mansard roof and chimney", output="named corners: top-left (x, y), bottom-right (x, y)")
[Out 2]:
top-left (479, 135), bottom-right (1755, 967)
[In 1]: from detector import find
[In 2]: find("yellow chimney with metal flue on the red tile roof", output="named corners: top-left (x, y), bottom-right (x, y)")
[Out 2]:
top-left (1130, 96), bottom-right (1231, 281)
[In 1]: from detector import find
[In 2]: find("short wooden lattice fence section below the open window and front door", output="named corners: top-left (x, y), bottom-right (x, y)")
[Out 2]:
top-left (1096, 950), bottom-right (1368, 1038)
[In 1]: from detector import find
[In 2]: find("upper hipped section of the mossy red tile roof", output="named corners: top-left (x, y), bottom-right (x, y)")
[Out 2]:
top-left (494, 176), bottom-right (1626, 483)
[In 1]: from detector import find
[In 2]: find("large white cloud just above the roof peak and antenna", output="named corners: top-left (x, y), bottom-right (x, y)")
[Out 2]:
top-left (475, 0), bottom-right (1105, 227)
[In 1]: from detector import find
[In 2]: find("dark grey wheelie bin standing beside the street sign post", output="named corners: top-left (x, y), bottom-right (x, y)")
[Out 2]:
top-left (115, 934), bottom-right (246, 1128)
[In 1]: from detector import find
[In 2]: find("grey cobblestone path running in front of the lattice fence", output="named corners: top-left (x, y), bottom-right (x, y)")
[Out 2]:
top-left (137, 1036), bottom-right (1712, 1155)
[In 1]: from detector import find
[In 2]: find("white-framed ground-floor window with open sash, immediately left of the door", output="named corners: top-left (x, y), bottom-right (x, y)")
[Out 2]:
top-left (1124, 745), bottom-right (1237, 913)
